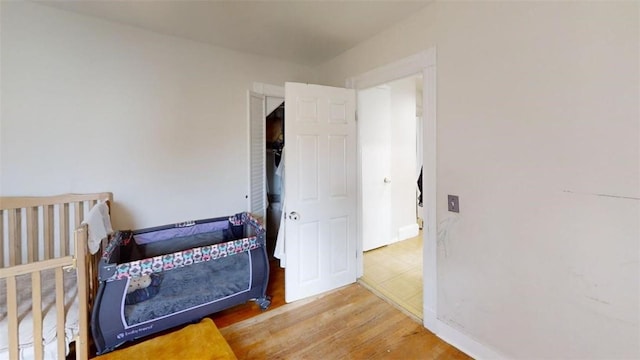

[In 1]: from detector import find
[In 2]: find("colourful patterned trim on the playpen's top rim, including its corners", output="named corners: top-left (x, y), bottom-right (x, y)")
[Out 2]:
top-left (102, 212), bottom-right (265, 281)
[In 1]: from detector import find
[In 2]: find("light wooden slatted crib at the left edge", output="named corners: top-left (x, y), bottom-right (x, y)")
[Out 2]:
top-left (0, 193), bottom-right (113, 359)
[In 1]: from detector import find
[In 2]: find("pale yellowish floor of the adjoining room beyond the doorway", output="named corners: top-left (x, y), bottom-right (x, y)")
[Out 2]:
top-left (361, 231), bottom-right (422, 320)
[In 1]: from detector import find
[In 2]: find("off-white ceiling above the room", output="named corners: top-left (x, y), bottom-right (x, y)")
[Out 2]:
top-left (39, 0), bottom-right (430, 66)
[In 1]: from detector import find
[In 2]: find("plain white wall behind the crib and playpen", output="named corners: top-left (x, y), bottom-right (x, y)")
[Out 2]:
top-left (0, 1), bottom-right (311, 228)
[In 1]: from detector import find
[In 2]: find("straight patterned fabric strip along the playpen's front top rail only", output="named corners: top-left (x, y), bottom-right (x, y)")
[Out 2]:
top-left (107, 236), bottom-right (262, 281)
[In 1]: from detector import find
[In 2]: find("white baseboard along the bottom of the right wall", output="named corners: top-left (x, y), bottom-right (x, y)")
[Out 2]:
top-left (423, 311), bottom-right (506, 360)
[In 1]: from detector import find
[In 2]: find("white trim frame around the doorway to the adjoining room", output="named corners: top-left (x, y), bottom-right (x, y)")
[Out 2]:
top-left (346, 47), bottom-right (439, 332)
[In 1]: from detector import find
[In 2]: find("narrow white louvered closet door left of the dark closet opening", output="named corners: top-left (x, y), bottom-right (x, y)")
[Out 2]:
top-left (249, 92), bottom-right (267, 223)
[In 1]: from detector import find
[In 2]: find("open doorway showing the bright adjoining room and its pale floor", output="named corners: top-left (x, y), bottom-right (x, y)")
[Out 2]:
top-left (358, 74), bottom-right (424, 320)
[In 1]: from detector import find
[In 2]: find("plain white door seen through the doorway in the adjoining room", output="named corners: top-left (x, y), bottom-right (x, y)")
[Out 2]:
top-left (358, 86), bottom-right (392, 251)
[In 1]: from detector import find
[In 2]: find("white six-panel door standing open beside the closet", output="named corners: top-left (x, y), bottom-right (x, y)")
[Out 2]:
top-left (284, 83), bottom-right (357, 302)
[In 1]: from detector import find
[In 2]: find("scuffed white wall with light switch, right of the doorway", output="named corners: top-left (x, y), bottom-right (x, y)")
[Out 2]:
top-left (317, 2), bottom-right (640, 359)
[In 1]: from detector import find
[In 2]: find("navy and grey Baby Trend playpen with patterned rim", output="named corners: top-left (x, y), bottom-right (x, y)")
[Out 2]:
top-left (92, 213), bottom-right (270, 354)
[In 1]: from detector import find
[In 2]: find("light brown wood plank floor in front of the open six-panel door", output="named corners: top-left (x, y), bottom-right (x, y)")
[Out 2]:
top-left (220, 284), bottom-right (469, 359)
